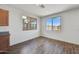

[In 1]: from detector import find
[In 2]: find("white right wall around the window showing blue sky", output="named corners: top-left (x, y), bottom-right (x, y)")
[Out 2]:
top-left (41, 9), bottom-right (79, 44)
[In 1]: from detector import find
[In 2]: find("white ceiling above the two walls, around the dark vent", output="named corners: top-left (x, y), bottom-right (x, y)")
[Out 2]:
top-left (12, 4), bottom-right (79, 16)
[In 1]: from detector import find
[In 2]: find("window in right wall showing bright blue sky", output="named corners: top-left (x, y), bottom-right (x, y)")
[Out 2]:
top-left (46, 16), bottom-right (61, 31)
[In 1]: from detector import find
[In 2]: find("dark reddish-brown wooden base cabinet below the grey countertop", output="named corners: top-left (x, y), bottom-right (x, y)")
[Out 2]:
top-left (0, 35), bottom-right (9, 52)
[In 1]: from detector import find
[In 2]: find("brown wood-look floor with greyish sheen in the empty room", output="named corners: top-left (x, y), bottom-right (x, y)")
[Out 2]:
top-left (8, 37), bottom-right (79, 54)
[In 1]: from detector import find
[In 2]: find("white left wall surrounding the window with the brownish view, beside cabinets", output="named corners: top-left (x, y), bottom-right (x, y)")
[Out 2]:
top-left (0, 5), bottom-right (40, 45)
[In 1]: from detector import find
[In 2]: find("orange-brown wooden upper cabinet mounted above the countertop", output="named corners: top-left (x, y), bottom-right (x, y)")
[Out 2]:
top-left (0, 9), bottom-right (9, 26)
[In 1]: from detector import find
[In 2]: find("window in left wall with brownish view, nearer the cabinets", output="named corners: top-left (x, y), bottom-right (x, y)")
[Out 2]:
top-left (22, 16), bottom-right (37, 30)
